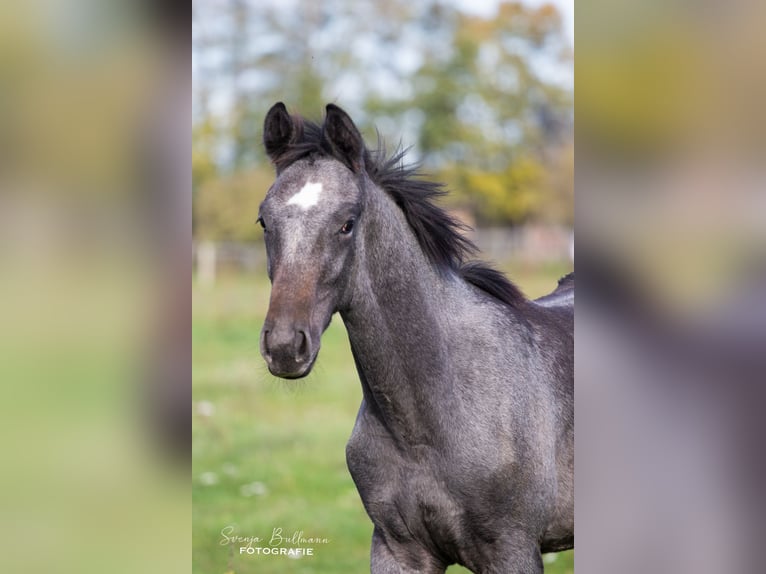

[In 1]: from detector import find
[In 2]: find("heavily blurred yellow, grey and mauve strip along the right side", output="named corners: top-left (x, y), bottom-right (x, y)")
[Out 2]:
top-left (575, 0), bottom-right (766, 574)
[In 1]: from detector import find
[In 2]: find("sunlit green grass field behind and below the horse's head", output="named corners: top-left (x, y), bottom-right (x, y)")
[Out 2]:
top-left (192, 264), bottom-right (574, 574)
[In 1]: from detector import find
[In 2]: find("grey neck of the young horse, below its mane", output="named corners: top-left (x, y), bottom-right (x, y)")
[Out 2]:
top-left (342, 190), bottom-right (460, 444)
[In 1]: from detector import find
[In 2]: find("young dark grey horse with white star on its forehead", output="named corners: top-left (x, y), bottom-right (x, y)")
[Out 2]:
top-left (257, 102), bottom-right (574, 574)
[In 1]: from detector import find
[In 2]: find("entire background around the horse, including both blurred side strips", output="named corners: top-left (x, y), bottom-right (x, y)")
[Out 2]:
top-left (0, 0), bottom-right (766, 574)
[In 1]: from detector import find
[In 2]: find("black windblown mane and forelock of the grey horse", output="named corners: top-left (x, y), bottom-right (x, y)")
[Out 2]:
top-left (275, 116), bottom-right (526, 307)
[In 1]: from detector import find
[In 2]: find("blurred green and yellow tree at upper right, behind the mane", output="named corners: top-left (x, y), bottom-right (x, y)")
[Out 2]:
top-left (370, 2), bottom-right (572, 224)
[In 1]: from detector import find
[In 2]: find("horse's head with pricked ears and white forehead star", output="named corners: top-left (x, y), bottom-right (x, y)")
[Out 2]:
top-left (258, 103), bottom-right (367, 378)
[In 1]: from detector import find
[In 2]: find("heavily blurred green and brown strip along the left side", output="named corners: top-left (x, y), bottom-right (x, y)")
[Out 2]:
top-left (0, 0), bottom-right (191, 574)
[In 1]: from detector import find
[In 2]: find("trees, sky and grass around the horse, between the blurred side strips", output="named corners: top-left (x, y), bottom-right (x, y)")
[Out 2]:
top-left (192, 0), bottom-right (574, 574)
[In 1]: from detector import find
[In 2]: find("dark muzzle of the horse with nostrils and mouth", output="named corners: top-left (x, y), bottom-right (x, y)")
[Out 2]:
top-left (261, 322), bottom-right (319, 379)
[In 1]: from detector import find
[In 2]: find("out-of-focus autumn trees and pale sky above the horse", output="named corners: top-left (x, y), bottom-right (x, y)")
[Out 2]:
top-left (193, 0), bottom-right (573, 237)
